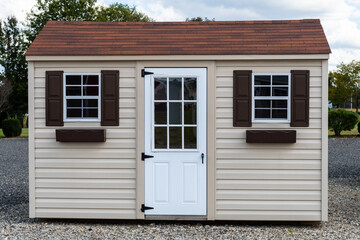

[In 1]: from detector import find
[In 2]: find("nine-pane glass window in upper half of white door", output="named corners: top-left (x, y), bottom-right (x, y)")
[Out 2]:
top-left (153, 77), bottom-right (198, 150)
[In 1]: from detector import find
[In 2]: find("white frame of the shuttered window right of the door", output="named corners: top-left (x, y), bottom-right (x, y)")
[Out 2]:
top-left (251, 73), bottom-right (291, 123)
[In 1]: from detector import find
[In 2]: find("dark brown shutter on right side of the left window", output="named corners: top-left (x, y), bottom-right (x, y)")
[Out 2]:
top-left (101, 71), bottom-right (119, 126)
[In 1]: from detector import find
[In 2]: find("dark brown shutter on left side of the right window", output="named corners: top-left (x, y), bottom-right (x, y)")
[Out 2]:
top-left (233, 70), bottom-right (252, 127)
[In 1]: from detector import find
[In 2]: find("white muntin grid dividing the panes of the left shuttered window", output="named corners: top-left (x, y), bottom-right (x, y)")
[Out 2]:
top-left (63, 73), bottom-right (101, 121)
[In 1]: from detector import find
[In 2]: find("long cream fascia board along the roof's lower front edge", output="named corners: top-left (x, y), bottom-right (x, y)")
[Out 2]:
top-left (26, 54), bottom-right (330, 62)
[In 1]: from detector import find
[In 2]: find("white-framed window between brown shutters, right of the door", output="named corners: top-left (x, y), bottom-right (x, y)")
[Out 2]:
top-left (252, 74), bottom-right (290, 122)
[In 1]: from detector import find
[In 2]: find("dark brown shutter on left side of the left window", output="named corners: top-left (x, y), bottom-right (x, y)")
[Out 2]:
top-left (45, 71), bottom-right (64, 126)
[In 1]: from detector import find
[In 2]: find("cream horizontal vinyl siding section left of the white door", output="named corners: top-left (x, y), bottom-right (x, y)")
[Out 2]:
top-left (34, 61), bottom-right (136, 219)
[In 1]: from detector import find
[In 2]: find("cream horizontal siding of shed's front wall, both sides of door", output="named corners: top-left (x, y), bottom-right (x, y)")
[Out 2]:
top-left (29, 60), bottom-right (327, 221)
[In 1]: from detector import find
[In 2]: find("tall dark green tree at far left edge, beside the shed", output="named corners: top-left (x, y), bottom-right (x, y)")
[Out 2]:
top-left (0, 16), bottom-right (28, 115)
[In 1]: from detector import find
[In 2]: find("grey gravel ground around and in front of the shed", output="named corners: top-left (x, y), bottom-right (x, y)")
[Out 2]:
top-left (0, 139), bottom-right (360, 239)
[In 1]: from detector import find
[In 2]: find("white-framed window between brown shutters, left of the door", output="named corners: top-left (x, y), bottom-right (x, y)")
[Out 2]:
top-left (64, 74), bottom-right (100, 121)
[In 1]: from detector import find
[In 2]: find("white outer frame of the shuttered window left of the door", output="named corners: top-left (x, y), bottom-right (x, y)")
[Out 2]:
top-left (63, 73), bottom-right (101, 122)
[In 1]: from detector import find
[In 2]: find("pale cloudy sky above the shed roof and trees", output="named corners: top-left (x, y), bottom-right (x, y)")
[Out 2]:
top-left (0, 0), bottom-right (360, 70)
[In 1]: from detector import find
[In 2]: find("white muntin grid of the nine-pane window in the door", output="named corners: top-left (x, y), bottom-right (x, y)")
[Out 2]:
top-left (151, 76), bottom-right (199, 151)
